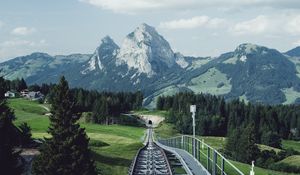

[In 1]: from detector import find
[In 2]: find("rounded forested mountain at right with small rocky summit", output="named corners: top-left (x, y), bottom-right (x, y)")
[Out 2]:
top-left (216, 44), bottom-right (300, 104)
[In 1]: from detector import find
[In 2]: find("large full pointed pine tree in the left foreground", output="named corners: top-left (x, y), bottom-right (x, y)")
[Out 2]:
top-left (33, 77), bottom-right (96, 175)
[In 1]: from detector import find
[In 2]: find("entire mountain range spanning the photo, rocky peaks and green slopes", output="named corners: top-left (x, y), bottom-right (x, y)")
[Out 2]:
top-left (0, 24), bottom-right (300, 107)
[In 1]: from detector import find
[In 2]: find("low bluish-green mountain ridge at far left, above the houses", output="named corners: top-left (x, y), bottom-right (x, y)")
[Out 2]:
top-left (0, 53), bottom-right (91, 84)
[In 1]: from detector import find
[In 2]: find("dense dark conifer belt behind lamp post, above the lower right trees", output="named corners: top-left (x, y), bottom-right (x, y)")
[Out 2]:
top-left (157, 93), bottom-right (300, 142)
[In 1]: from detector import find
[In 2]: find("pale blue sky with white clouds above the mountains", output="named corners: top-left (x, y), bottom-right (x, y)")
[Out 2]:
top-left (0, 0), bottom-right (300, 62)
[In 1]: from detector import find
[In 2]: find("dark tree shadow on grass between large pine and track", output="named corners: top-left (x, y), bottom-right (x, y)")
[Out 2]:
top-left (92, 151), bottom-right (132, 167)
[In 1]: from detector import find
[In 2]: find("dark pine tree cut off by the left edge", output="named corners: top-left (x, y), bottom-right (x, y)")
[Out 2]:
top-left (0, 77), bottom-right (23, 175)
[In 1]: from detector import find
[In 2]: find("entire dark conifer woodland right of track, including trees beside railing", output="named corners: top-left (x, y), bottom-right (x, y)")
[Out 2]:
top-left (157, 93), bottom-right (300, 173)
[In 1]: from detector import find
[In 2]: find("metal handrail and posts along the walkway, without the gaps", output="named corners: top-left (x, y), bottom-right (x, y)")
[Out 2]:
top-left (158, 135), bottom-right (244, 175)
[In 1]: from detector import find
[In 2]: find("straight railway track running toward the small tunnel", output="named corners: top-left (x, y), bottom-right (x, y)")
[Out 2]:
top-left (129, 128), bottom-right (173, 175)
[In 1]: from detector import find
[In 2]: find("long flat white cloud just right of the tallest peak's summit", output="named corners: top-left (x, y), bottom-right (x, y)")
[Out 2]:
top-left (159, 16), bottom-right (225, 29)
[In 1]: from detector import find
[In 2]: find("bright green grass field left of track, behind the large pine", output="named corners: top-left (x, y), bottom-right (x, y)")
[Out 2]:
top-left (8, 99), bottom-right (145, 175)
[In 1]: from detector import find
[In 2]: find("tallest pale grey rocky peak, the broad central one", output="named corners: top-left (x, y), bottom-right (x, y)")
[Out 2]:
top-left (117, 23), bottom-right (175, 76)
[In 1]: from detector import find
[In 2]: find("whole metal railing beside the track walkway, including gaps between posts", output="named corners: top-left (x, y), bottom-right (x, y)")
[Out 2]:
top-left (158, 135), bottom-right (244, 175)
